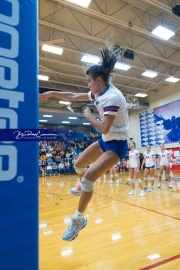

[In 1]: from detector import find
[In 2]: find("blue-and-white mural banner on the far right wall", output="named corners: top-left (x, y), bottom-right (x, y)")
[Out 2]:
top-left (139, 99), bottom-right (180, 147)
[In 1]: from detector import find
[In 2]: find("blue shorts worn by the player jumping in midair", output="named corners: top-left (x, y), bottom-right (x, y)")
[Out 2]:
top-left (98, 138), bottom-right (128, 160)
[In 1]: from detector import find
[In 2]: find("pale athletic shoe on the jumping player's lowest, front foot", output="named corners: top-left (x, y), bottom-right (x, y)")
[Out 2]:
top-left (62, 217), bottom-right (87, 241)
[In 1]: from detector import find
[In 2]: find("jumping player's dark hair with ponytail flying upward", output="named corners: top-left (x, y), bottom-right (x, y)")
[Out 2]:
top-left (86, 43), bottom-right (122, 84)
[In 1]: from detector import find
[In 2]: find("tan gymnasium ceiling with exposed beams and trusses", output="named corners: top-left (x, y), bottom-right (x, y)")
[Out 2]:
top-left (39, 0), bottom-right (180, 125)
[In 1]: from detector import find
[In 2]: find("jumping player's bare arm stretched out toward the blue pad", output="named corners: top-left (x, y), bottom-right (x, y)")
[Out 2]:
top-left (39, 91), bottom-right (89, 102)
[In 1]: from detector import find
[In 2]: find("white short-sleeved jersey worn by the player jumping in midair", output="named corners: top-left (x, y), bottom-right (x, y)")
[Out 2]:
top-left (88, 84), bottom-right (129, 142)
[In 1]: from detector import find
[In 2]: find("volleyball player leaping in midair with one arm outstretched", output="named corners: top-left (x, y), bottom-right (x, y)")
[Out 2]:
top-left (40, 44), bottom-right (129, 241)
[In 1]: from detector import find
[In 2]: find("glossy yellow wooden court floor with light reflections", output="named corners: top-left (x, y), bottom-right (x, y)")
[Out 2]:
top-left (39, 172), bottom-right (180, 270)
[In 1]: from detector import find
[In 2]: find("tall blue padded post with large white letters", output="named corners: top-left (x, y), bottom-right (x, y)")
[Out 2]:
top-left (0, 0), bottom-right (38, 270)
